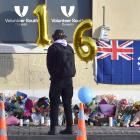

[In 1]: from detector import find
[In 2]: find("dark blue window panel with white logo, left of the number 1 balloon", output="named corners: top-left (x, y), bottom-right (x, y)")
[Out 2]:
top-left (0, 0), bottom-right (44, 43)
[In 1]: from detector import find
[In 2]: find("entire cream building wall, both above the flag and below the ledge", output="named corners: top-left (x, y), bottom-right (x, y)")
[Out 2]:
top-left (0, 0), bottom-right (140, 101)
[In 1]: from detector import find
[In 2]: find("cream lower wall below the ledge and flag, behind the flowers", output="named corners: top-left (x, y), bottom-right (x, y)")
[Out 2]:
top-left (0, 54), bottom-right (140, 102)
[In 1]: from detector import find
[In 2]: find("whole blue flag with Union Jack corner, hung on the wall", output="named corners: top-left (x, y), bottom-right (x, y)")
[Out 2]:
top-left (95, 40), bottom-right (140, 84)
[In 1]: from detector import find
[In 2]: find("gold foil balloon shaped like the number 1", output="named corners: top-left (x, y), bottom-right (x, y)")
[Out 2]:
top-left (33, 4), bottom-right (51, 47)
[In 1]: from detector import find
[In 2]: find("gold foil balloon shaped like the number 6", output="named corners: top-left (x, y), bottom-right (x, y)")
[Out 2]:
top-left (73, 19), bottom-right (97, 62)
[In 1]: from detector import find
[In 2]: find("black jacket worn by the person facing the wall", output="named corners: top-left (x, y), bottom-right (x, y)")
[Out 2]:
top-left (46, 43), bottom-right (76, 79)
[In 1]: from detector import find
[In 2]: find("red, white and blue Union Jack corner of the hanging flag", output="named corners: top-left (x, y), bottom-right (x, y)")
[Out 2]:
top-left (97, 40), bottom-right (134, 60)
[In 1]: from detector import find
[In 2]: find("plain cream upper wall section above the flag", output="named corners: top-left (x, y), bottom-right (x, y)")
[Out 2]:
top-left (93, 0), bottom-right (140, 40)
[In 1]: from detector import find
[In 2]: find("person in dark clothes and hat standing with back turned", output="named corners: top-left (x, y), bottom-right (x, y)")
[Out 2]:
top-left (46, 29), bottom-right (76, 135)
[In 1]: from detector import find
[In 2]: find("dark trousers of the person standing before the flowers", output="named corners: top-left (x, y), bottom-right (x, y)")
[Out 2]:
top-left (49, 78), bottom-right (73, 127)
